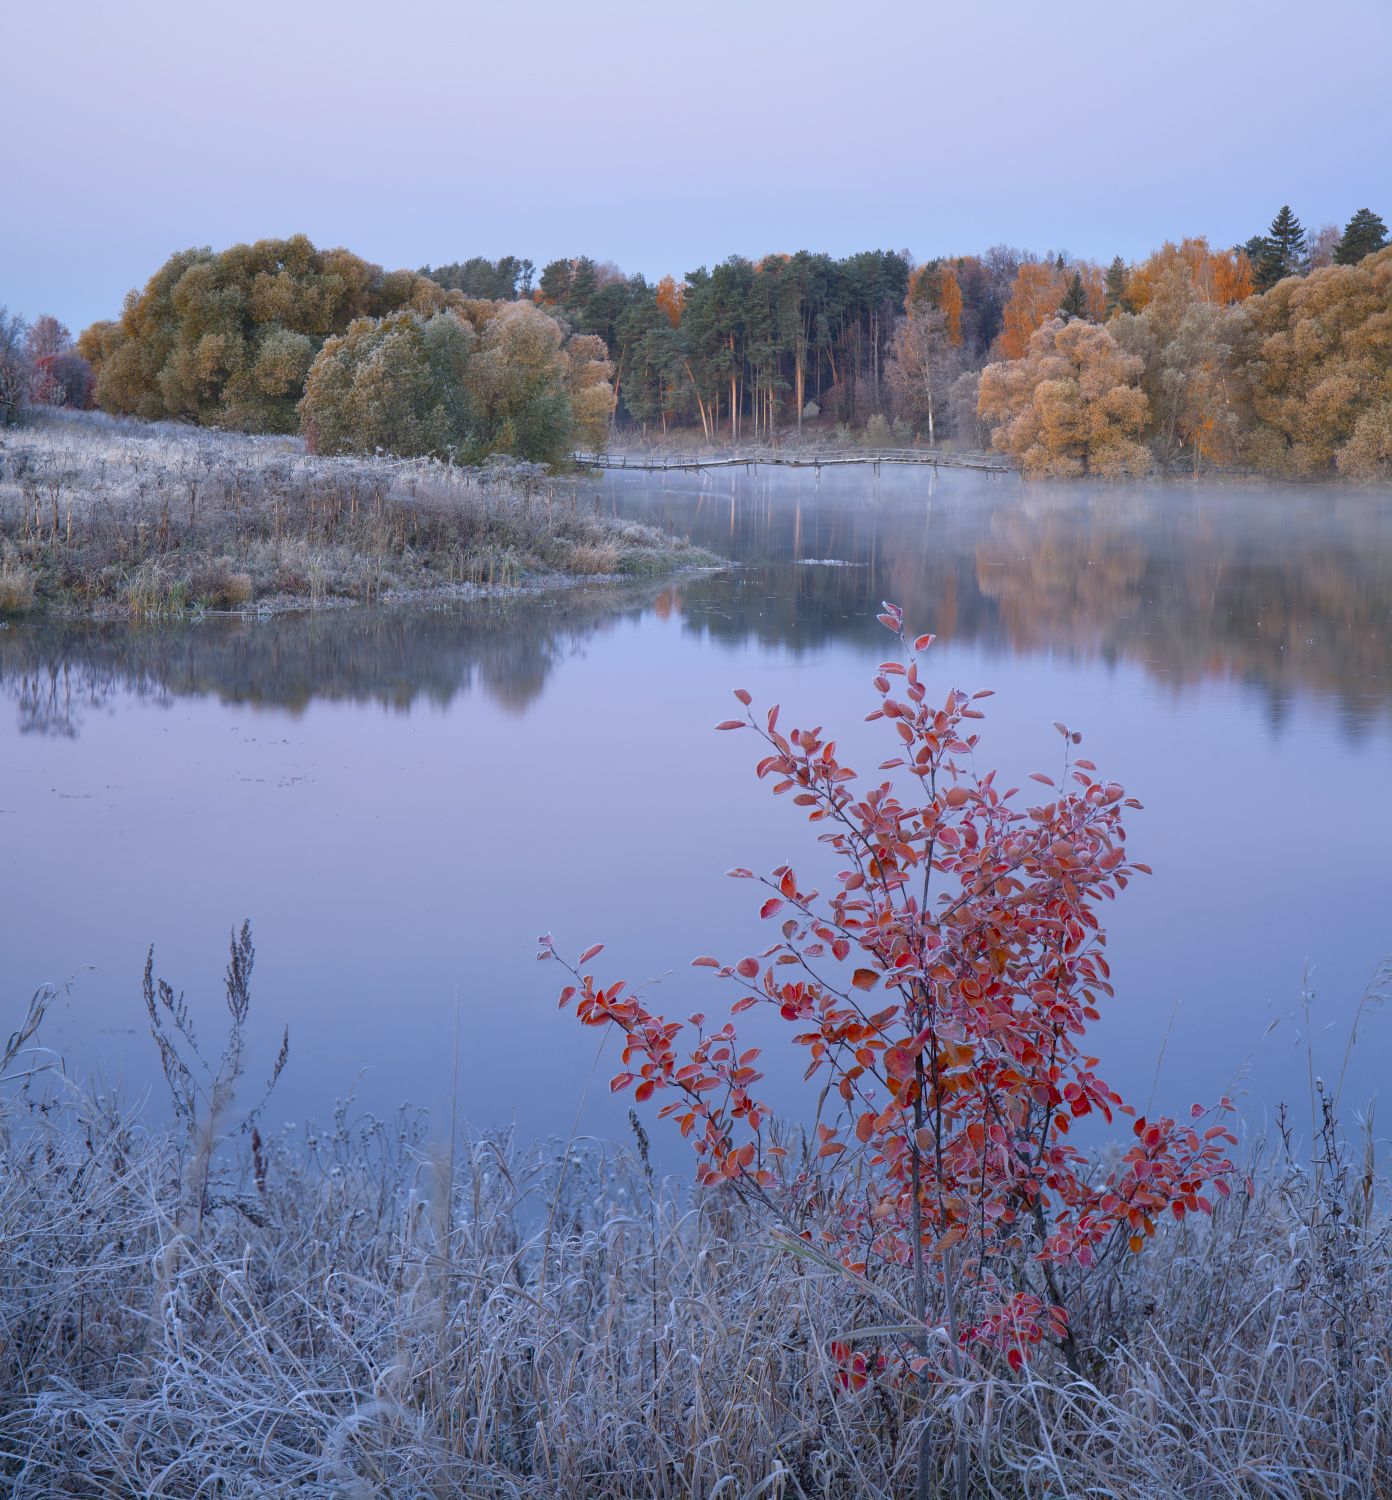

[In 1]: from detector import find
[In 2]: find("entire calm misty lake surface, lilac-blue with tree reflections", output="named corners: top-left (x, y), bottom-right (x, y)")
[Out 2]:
top-left (0, 470), bottom-right (1392, 1137)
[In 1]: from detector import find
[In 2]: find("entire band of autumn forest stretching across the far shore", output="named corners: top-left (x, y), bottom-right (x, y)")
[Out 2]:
top-left (0, 206), bottom-right (1392, 480)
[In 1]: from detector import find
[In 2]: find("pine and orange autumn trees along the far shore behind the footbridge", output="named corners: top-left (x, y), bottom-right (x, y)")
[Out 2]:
top-left (422, 206), bottom-right (1392, 477)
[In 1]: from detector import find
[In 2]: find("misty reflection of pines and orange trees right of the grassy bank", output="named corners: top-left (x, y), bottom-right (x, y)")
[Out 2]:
top-left (611, 470), bottom-right (1392, 734)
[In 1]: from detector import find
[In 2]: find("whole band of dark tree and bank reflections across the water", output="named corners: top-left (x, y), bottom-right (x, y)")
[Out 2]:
top-left (0, 470), bottom-right (1392, 735)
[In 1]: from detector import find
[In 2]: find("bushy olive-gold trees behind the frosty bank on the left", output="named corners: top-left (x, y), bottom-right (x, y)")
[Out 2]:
top-left (0, 236), bottom-right (614, 462)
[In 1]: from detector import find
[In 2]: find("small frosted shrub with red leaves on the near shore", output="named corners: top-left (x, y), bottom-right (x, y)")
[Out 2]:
top-left (539, 605), bottom-right (1233, 1452)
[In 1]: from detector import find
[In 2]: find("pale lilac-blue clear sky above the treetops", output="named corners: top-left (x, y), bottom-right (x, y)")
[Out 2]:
top-left (0, 0), bottom-right (1392, 332)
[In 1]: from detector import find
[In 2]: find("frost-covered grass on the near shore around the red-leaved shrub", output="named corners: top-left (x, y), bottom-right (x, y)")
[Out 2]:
top-left (0, 950), bottom-right (1392, 1500)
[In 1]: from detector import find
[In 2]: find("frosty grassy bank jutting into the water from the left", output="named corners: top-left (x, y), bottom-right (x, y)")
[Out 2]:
top-left (0, 413), bottom-right (713, 618)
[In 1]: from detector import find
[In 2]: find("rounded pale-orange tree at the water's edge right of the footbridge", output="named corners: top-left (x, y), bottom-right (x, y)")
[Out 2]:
top-left (978, 318), bottom-right (1151, 479)
